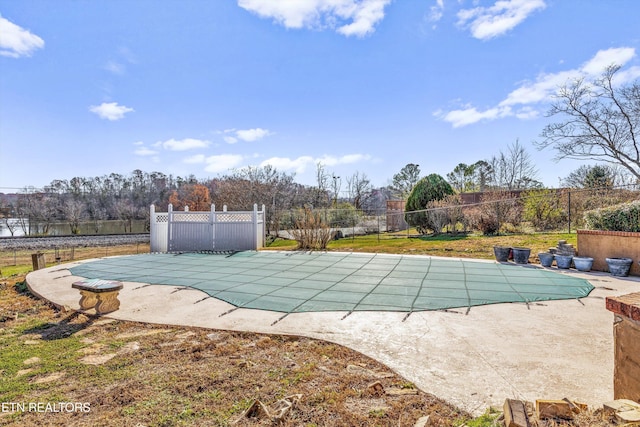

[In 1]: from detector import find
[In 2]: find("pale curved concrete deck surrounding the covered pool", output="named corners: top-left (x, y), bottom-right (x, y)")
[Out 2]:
top-left (27, 256), bottom-right (640, 414)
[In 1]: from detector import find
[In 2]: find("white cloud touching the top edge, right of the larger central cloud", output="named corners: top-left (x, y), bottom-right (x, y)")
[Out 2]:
top-left (458, 0), bottom-right (546, 40)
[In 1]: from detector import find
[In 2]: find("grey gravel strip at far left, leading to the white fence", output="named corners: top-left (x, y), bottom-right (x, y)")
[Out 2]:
top-left (0, 234), bottom-right (149, 251)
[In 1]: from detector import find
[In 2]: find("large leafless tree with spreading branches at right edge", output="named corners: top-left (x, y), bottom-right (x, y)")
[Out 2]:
top-left (536, 65), bottom-right (640, 180)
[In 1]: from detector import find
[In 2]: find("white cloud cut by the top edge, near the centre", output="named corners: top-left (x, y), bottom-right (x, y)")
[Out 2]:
top-left (238, 0), bottom-right (391, 37)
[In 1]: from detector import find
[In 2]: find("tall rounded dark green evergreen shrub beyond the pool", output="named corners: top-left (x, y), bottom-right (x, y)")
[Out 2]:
top-left (405, 173), bottom-right (454, 234)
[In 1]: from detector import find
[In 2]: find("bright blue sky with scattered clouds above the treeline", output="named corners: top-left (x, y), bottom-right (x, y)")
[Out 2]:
top-left (0, 0), bottom-right (640, 192)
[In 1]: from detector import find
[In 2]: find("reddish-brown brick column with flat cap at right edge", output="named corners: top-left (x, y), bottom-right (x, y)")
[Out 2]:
top-left (606, 292), bottom-right (640, 402)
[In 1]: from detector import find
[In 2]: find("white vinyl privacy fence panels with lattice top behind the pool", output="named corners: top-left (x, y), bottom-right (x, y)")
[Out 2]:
top-left (150, 205), bottom-right (265, 252)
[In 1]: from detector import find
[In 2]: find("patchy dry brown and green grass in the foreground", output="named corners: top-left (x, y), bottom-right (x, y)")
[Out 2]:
top-left (0, 277), bottom-right (467, 426)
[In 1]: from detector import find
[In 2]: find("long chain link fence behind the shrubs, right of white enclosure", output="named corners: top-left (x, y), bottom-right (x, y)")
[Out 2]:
top-left (269, 186), bottom-right (640, 239)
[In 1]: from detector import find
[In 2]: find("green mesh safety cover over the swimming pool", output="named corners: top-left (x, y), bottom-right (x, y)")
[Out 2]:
top-left (70, 251), bottom-right (593, 313)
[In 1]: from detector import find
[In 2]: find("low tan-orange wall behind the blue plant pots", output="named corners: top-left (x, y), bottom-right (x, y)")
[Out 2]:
top-left (578, 230), bottom-right (640, 276)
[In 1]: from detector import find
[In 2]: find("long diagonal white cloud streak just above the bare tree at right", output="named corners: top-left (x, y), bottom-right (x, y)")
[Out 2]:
top-left (434, 48), bottom-right (640, 128)
